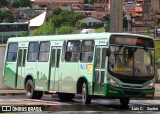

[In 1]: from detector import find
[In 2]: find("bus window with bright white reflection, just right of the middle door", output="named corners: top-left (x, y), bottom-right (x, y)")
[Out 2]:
top-left (65, 40), bottom-right (81, 62)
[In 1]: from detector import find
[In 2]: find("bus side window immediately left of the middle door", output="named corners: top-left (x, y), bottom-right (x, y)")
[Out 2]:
top-left (39, 42), bottom-right (50, 62)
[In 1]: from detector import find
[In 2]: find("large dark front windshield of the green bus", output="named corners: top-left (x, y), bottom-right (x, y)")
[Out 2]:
top-left (109, 46), bottom-right (154, 77)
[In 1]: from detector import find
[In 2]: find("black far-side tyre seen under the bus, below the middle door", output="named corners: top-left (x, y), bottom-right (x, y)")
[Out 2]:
top-left (58, 93), bottom-right (75, 101)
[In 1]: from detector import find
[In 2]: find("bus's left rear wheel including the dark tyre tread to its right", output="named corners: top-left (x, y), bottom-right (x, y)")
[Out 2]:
top-left (25, 79), bottom-right (43, 99)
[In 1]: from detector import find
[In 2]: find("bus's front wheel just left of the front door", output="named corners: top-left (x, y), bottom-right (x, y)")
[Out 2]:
top-left (82, 82), bottom-right (91, 105)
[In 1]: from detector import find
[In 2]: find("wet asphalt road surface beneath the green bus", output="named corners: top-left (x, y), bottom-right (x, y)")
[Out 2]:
top-left (0, 95), bottom-right (160, 114)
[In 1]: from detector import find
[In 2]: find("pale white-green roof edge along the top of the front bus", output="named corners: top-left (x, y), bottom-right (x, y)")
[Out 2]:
top-left (8, 32), bottom-right (153, 42)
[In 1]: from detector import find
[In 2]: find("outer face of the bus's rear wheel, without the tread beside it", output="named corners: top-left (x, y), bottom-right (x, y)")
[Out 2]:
top-left (26, 79), bottom-right (35, 99)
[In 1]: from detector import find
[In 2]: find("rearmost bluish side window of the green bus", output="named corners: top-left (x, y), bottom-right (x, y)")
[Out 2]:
top-left (7, 43), bottom-right (18, 62)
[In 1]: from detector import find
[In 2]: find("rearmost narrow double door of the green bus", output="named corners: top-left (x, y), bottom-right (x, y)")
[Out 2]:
top-left (16, 48), bottom-right (27, 89)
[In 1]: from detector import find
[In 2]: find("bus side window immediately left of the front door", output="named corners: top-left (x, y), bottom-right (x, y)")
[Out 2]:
top-left (80, 40), bottom-right (94, 62)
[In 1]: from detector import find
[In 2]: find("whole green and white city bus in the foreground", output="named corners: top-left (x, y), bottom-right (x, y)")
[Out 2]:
top-left (3, 33), bottom-right (155, 106)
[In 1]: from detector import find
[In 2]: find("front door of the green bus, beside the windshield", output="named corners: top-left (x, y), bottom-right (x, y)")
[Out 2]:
top-left (93, 46), bottom-right (106, 95)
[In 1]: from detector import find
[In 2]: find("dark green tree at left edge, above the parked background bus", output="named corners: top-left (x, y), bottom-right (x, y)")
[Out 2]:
top-left (0, 8), bottom-right (14, 23)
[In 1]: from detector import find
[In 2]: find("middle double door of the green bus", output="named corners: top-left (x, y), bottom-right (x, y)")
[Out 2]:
top-left (49, 47), bottom-right (61, 91)
